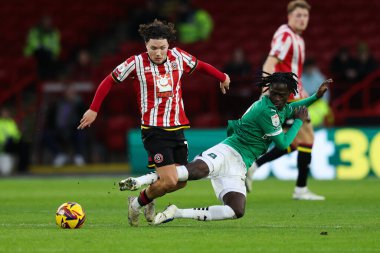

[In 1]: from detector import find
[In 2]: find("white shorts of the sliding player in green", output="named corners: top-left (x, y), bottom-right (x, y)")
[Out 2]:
top-left (194, 143), bottom-right (247, 203)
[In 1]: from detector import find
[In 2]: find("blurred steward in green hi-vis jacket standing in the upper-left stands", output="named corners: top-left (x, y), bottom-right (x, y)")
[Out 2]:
top-left (24, 16), bottom-right (60, 80)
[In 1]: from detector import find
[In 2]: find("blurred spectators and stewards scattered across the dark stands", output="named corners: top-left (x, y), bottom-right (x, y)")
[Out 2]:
top-left (0, 0), bottom-right (378, 173)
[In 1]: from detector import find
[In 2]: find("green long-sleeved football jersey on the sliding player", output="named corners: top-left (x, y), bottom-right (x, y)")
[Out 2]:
top-left (222, 95), bottom-right (317, 169)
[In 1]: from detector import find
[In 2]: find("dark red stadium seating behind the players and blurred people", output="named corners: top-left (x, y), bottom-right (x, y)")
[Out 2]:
top-left (0, 0), bottom-right (380, 172)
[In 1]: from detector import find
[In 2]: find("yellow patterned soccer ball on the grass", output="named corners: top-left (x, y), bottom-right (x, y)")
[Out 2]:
top-left (55, 202), bottom-right (86, 228)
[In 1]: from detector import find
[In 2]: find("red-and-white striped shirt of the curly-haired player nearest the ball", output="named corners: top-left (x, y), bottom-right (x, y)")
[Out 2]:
top-left (112, 48), bottom-right (197, 127)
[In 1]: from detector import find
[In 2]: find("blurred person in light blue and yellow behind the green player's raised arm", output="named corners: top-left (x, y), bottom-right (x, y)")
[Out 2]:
top-left (301, 58), bottom-right (334, 127)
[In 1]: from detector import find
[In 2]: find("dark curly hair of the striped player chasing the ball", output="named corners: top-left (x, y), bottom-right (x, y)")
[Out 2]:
top-left (139, 19), bottom-right (176, 42)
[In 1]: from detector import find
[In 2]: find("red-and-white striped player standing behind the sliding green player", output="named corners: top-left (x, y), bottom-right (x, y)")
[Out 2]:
top-left (246, 0), bottom-right (325, 200)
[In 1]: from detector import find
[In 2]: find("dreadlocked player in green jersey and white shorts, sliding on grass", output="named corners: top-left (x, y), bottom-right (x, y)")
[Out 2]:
top-left (120, 72), bottom-right (332, 225)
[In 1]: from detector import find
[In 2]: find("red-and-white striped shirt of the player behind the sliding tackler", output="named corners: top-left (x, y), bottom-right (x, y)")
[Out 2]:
top-left (269, 24), bottom-right (305, 99)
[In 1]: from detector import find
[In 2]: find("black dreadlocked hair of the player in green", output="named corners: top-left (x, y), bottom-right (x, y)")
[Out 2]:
top-left (256, 71), bottom-right (298, 95)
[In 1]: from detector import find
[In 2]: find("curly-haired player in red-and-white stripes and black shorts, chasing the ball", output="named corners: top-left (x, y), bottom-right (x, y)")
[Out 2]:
top-left (78, 20), bottom-right (230, 226)
